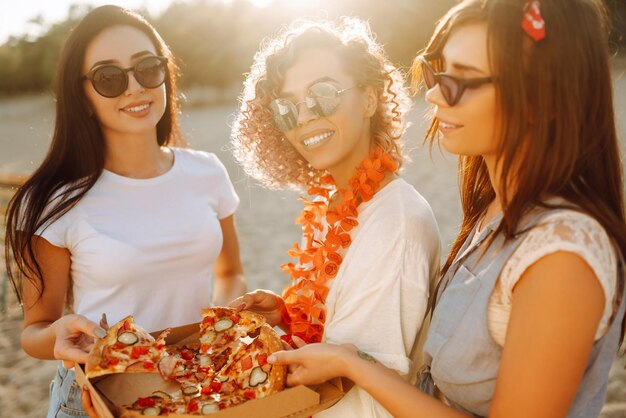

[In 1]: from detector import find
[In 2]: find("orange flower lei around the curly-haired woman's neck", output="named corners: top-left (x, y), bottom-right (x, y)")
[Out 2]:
top-left (281, 148), bottom-right (398, 345)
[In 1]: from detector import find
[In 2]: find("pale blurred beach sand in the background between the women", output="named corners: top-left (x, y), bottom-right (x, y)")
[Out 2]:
top-left (0, 68), bottom-right (626, 418)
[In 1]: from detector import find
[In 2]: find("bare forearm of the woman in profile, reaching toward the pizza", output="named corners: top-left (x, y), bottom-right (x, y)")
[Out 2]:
top-left (344, 355), bottom-right (467, 418)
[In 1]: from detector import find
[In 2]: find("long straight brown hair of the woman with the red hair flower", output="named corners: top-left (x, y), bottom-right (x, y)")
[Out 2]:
top-left (413, 0), bottom-right (626, 341)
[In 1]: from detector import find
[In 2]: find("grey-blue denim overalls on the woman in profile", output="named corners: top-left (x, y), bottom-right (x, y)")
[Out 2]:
top-left (417, 209), bottom-right (626, 418)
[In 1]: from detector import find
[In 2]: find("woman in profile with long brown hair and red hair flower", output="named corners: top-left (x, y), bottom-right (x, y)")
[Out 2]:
top-left (270, 0), bottom-right (626, 418)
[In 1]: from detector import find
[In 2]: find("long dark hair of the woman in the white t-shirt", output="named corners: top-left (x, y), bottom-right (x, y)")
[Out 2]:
top-left (5, 6), bottom-right (183, 302)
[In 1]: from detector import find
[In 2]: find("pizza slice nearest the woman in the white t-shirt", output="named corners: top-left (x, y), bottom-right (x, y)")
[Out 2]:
top-left (85, 315), bottom-right (170, 378)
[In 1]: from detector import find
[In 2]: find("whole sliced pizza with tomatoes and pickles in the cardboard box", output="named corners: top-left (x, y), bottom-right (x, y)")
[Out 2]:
top-left (86, 307), bottom-right (285, 416)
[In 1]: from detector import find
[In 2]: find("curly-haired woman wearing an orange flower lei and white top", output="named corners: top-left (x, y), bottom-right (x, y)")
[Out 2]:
top-left (231, 19), bottom-right (440, 418)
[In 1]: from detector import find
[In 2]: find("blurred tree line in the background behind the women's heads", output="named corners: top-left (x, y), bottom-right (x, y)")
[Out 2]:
top-left (0, 0), bottom-right (626, 95)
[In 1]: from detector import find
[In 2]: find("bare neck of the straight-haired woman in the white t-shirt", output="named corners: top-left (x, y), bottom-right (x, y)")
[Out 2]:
top-left (104, 131), bottom-right (174, 179)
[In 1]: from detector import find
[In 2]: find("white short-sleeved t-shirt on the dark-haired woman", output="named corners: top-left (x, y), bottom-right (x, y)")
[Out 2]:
top-left (37, 149), bottom-right (239, 331)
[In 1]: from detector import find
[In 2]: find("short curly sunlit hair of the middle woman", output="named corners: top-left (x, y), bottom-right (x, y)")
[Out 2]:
top-left (231, 18), bottom-right (410, 189)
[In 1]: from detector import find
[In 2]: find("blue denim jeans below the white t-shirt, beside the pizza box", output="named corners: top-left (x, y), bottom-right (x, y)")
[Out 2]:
top-left (46, 362), bottom-right (88, 418)
